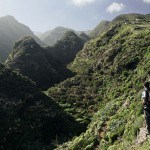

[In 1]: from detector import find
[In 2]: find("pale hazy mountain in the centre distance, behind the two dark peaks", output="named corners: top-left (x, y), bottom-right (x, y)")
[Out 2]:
top-left (39, 27), bottom-right (73, 46)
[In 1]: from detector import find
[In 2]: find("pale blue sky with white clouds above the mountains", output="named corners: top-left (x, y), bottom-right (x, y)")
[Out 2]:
top-left (0, 0), bottom-right (150, 32)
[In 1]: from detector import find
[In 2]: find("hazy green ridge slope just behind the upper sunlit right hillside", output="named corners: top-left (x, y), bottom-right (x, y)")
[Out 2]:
top-left (88, 20), bottom-right (109, 38)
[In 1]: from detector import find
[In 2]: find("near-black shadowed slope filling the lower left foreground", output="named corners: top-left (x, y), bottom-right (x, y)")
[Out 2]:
top-left (0, 64), bottom-right (83, 150)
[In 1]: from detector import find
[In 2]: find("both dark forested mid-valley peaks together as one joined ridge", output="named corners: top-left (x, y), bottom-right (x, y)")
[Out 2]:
top-left (5, 32), bottom-right (85, 89)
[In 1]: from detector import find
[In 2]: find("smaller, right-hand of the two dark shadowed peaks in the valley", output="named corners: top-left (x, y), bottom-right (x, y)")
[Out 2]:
top-left (47, 31), bottom-right (87, 64)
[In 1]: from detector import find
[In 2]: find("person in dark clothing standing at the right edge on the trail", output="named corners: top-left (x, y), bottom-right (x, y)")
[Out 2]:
top-left (142, 82), bottom-right (150, 134)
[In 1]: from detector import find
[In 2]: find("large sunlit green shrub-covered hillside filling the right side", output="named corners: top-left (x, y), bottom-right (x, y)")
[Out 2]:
top-left (47, 14), bottom-right (150, 150)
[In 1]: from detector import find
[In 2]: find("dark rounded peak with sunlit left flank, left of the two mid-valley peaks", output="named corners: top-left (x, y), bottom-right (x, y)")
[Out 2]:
top-left (5, 36), bottom-right (72, 88)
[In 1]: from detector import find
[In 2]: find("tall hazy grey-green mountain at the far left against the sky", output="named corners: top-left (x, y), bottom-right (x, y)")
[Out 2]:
top-left (0, 16), bottom-right (44, 62)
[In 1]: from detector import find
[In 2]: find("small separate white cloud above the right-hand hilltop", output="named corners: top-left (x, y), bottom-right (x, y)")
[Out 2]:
top-left (106, 2), bottom-right (126, 14)
